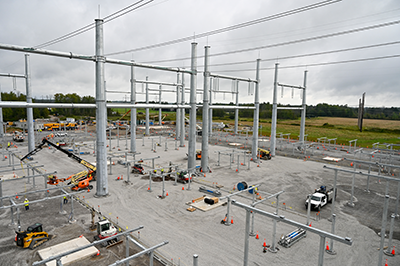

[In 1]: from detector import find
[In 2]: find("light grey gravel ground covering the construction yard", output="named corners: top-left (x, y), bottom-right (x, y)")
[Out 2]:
top-left (0, 131), bottom-right (400, 266)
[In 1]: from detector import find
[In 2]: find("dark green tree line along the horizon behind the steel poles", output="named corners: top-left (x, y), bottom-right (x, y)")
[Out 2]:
top-left (1, 91), bottom-right (400, 121)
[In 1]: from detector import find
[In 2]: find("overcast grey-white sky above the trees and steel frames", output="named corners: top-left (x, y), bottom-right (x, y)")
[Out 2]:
top-left (0, 0), bottom-right (400, 107)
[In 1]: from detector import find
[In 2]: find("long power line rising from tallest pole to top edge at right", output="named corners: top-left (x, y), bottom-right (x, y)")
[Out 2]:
top-left (106, 0), bottom-right (342, 56)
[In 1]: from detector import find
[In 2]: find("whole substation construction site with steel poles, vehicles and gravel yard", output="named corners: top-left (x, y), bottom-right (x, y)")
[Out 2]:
top-left (0, 1), bottom-right (400, 266)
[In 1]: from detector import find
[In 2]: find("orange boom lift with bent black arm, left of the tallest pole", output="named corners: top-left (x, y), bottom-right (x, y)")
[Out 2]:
top-left (21, 138), bottom-right (96, 190)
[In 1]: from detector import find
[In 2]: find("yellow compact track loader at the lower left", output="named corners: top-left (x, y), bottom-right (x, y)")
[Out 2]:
top-left (15, 223), bottom-right (52, 249)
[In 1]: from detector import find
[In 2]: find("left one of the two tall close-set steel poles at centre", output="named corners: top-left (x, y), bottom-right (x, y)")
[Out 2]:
top-left (188, 43), bottom-right (197, 170)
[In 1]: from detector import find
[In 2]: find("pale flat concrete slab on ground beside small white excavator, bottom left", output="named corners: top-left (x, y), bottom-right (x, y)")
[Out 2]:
top-left (38, 236), bottom-right (99, 266)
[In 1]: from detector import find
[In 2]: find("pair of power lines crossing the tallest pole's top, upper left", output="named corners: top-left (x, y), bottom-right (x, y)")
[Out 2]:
top-left (33, 0), bottom-right (154, 49)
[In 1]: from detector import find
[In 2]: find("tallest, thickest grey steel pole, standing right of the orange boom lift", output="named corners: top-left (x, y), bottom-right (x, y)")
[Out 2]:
top-left (95, 19), bottom-right (108, 197)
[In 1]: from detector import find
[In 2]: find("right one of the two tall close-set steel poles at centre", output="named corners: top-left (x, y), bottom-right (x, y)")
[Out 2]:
top-left (202, 46), bottom-right (210, 172)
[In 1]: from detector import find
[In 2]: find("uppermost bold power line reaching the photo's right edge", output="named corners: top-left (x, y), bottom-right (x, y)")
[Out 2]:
top-left (142, 20), bottom-right (400, 63)
